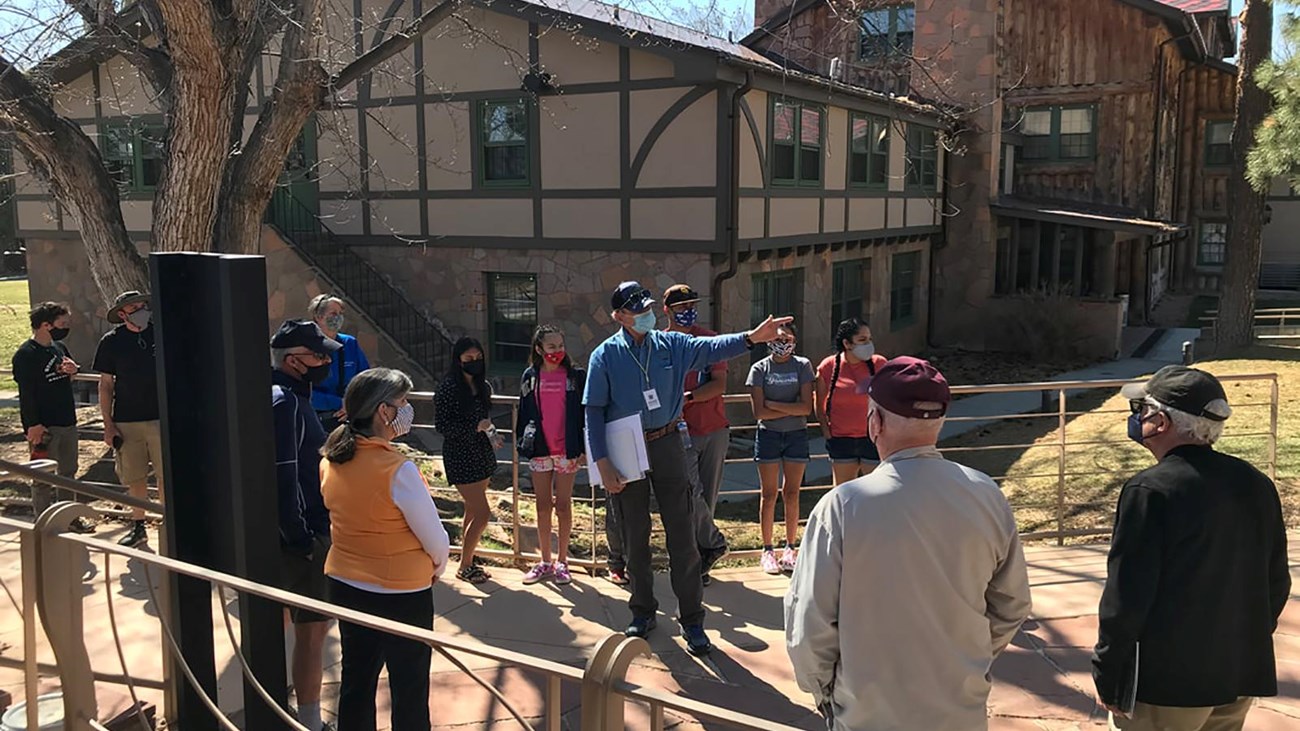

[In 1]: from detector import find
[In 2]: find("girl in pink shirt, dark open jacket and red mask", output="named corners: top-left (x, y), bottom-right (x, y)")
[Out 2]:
top-left (517, 325), bottom-right (586, 584)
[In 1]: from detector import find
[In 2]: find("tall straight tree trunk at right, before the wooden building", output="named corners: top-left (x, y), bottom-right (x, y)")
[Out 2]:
top-left (1214, 0), bottom-right (1273, 349)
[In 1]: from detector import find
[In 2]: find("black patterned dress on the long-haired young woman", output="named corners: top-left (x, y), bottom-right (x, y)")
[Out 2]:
top-left (433, 377), bottom-right (497, 485)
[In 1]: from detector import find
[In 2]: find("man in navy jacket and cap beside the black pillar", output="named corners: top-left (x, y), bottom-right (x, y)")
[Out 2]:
top-left (270, 320), bottom-right (342, 731)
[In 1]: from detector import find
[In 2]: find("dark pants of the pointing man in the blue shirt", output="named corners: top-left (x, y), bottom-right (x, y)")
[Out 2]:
top-left (614, 434), bottom-right (705, 624)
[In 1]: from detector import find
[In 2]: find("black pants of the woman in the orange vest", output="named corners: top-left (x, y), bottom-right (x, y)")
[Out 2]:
top-left (329, 579), bottom-right (433, 731)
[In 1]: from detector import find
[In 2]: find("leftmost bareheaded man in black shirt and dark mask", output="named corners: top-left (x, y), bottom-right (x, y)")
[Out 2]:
top-left (13, 302), bottom-right (94, 532)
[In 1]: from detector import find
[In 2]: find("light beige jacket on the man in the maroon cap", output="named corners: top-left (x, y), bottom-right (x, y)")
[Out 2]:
top-left (785, 447), bottom-right (1030, 731)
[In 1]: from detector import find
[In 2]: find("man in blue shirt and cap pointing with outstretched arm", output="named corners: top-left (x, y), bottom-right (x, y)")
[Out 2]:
top-left (582, 282), bottom-right (793, 657)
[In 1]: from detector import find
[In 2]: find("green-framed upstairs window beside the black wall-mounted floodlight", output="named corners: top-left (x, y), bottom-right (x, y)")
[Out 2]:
top-left (475, 99), bottom-right (534, 187)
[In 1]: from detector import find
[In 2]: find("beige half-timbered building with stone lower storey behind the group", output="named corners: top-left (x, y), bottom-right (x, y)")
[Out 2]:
top-left (17, 0), bottom-right (945, 382)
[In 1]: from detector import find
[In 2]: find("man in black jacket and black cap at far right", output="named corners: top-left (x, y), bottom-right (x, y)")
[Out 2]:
top-left (1092, 366), bottom-right (1291, 731)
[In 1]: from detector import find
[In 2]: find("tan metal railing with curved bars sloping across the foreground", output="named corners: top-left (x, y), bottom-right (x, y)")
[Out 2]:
top-left (0, 504), bottom-right (796, 731)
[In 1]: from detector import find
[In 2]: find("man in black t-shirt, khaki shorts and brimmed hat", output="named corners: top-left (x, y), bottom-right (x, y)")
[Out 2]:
top-left (94, 291), bottom-right (163, 548)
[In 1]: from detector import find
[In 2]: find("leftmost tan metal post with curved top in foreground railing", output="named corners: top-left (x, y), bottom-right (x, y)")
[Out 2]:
top-left (27, 502), bottom-right (99, 731)
